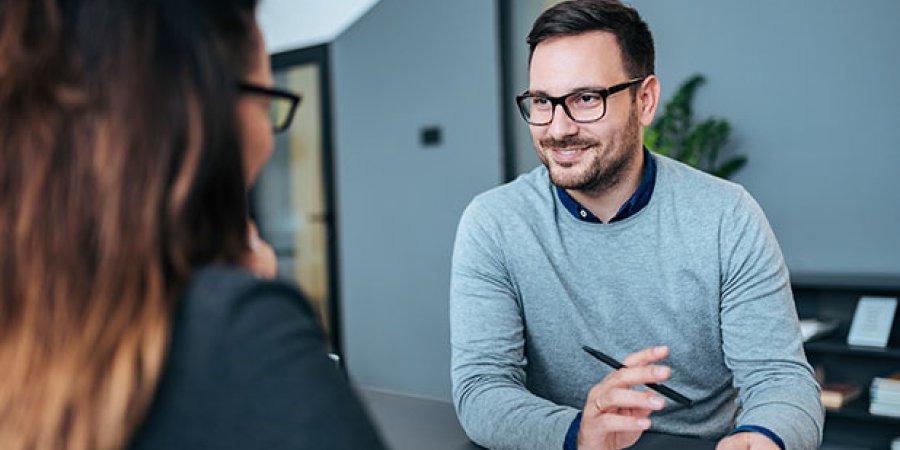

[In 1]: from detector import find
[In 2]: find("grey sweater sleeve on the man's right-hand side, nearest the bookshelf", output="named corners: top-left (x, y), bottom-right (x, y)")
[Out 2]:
top-left (719, 190), bottom-right (824, 450)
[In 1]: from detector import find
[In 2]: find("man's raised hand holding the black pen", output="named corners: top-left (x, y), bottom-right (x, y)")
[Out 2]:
top-left (578, 346), bottom-right (671, 450)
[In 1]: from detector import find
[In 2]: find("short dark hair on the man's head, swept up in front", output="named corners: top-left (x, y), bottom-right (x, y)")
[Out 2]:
top-left (526, 0), bottom-right (655, 78)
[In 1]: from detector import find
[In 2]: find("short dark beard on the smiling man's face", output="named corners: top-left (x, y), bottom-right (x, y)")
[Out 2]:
top-left (538, 109), bottom-right (641, 193)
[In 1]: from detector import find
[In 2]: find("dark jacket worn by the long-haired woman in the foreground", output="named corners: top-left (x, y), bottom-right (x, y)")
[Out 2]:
top-left (129, 267), bottom-right (384, 450)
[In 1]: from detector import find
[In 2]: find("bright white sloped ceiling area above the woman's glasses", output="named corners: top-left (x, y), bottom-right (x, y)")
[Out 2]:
top-left (257, 0), bottom-right (378, 53)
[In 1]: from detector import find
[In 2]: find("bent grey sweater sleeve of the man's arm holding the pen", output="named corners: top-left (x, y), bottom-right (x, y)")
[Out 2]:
top-left (450, 198), bottom-right (578, 450)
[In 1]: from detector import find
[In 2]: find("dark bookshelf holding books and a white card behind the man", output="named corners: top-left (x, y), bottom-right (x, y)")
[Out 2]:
top-left (791, 274), bottom-right (900, 450)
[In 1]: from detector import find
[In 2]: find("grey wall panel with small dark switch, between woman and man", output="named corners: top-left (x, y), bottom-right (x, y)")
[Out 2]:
top-left (331, 0), bottom-right (501, 399)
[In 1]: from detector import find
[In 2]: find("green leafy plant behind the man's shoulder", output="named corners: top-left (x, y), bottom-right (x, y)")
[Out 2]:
top-left (644, 74), bottom-right (747, 179)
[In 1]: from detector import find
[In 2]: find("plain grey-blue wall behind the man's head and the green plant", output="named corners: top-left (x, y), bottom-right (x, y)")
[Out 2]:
top-left (516, 0), bottom-right (900, 275)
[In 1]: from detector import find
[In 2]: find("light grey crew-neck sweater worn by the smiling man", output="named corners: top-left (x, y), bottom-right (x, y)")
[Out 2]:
top-left (450, 155), bottom-right (824, 450)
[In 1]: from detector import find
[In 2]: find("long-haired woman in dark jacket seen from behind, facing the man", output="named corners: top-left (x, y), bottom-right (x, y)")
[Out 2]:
top-left (0, 0), bottom-right (382, 450)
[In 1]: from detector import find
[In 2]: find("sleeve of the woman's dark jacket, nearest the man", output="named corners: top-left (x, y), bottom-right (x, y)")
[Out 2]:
top-left (216, 282), bottom-right (384, 450)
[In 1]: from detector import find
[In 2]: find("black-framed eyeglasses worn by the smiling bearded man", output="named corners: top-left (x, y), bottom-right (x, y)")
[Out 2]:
top-left (516, 77), bottom-right (647, 126)
